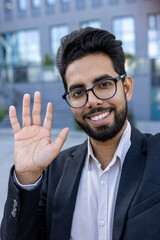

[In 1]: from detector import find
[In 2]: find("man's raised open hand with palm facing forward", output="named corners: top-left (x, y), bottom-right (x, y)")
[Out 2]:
top-left (9, 92), bottom-right (69, 184)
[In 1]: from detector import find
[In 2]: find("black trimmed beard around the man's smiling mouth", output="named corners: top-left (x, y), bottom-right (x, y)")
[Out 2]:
top-left (75, 99), bottom-right (128, 142)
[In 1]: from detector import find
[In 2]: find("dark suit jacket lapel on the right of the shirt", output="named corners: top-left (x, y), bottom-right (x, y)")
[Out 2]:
top-left (113, 128), bottom-right (146, 240)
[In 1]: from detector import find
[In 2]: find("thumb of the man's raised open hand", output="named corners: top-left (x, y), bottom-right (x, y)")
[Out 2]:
top-left (51, 128), bottom-right (69, 159)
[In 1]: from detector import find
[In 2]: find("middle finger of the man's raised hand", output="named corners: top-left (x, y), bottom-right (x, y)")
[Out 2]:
top-left (32, 91), bottom-right (41, 126)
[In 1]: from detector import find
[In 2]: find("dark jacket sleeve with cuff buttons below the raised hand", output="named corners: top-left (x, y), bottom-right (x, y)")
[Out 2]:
top-left (0, 168), bottom-right (46, 240)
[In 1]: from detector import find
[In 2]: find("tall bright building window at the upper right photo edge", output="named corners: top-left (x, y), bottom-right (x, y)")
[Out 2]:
top-left (148, 13), bottom-right (160, 58)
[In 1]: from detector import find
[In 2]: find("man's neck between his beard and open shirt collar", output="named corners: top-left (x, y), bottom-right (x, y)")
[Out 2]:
top-left (90, 120), bottom-right (127, 170)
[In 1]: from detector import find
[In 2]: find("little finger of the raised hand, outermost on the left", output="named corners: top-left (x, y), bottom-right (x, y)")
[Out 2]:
top-left (9, 106), bottom-right (21, 134)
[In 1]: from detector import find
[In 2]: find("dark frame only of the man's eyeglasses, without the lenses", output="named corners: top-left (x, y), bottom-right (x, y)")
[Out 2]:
top-left (62, 73), bottom-right (126, 109)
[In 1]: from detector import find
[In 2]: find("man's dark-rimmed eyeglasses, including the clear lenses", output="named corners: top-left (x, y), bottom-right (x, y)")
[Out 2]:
top-left (62, 74), bottom-right (126, 108)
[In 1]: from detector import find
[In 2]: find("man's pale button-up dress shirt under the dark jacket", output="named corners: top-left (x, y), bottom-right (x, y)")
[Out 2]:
top-left (70, 123), bottom-right (131, 240)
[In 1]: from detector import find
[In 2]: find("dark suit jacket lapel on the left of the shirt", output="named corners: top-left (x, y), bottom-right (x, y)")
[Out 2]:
top-left (51, 142), bottom-right (87, 240)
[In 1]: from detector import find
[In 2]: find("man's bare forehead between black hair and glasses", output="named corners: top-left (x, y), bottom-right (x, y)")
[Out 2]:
top-left (65, 54), bottom-right (118, 89)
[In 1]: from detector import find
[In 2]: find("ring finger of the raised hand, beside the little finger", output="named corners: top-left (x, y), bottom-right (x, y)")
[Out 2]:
top-left (22, 93), bottom-right (31, 127)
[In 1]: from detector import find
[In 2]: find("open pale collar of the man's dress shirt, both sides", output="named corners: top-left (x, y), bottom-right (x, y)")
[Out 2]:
top-left (86, 121), bottom-right (131, 169)
